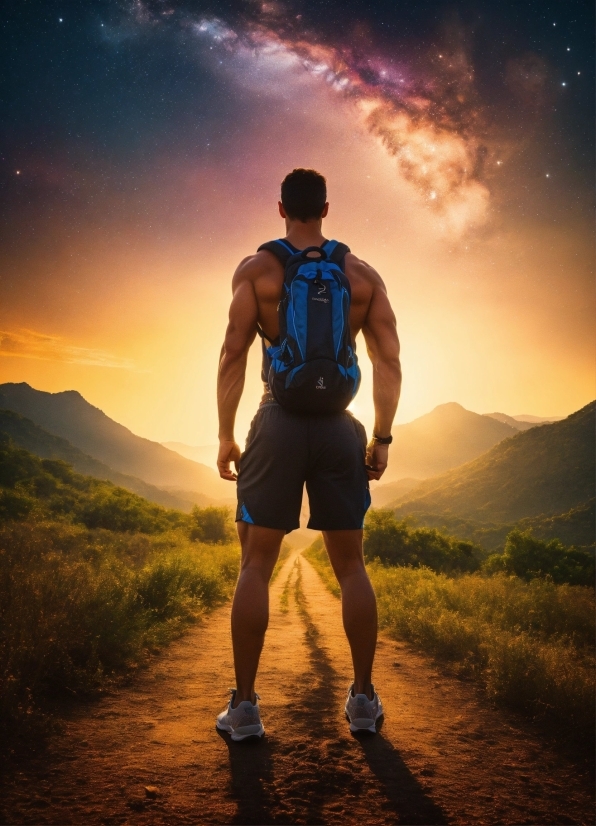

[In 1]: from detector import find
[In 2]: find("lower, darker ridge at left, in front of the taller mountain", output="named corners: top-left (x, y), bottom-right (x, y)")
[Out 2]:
top-left (0, 410), bottom-right (205, 511)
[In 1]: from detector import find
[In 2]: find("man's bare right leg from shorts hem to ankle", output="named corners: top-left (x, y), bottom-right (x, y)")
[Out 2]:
top-left (323, 530), bottom-right (377, 699)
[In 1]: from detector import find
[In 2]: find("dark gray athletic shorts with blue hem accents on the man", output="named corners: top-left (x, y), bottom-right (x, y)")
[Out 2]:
top-left (236, 402), bottom-right (370, 533)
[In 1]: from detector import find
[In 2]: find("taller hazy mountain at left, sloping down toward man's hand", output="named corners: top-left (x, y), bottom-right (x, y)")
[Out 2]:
top-left (0, 382), bottom-right (234, 499)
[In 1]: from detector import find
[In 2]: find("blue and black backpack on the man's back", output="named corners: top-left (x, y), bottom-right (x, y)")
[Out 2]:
top-left (259, 239), bottom-right (360, 413)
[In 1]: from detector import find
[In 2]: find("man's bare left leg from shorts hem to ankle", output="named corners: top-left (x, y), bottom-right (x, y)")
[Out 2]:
top-left (232, 522), bottom-right (285, 705)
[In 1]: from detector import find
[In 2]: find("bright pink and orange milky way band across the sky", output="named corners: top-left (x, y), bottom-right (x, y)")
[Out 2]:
top-left (132, 2), bottom-right (494, 234)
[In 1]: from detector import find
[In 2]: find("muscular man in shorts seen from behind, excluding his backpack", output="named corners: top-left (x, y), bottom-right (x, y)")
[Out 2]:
top-left (217, 169), bottom-right (401, 740)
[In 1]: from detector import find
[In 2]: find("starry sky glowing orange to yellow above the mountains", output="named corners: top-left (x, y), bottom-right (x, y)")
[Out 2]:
top-left (0, 0), bottom-right (596, 445)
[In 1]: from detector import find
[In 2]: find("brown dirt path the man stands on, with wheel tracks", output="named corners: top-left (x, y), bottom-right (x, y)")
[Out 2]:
top-left (0, 554), bottom-right (594, 826)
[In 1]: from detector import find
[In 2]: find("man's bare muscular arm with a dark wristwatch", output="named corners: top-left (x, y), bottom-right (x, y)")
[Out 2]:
top-left (362, 273), bottom-right (401, 479)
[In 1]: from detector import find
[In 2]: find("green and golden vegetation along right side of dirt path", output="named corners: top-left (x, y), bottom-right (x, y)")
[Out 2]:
top-left (305, 510), bottom-right (596, 732)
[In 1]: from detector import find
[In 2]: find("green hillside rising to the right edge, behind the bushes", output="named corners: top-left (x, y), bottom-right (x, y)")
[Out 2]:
top-left (394, 402), bottom-right (596, 523)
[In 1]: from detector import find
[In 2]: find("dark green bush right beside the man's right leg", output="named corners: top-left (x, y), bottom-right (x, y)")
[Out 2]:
top-left (364, 509), bottom-right (483, 573)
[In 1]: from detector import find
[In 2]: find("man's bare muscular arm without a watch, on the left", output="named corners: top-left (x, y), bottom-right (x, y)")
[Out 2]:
top-left (217, 258), bottom-right (258, 482)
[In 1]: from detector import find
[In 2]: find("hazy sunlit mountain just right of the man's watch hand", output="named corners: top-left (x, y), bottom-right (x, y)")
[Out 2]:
top-left (383, 402), bottom-right (519, 482)
